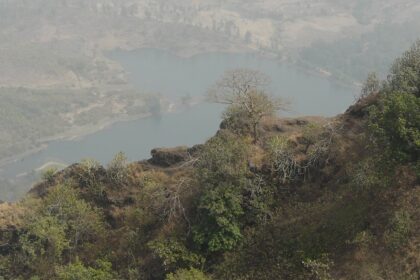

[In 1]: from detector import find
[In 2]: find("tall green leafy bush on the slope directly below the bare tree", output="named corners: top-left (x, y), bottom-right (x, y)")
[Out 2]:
top-left (193, 133), bottom-right (247, 252)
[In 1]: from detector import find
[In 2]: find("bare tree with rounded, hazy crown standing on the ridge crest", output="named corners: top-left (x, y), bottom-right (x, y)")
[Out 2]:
top-left (208, 69), bottom-right (286, 142)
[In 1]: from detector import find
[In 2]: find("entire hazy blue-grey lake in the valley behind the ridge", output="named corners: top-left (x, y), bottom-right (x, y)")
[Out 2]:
top-left (0, 49), bottom-right (355, 200)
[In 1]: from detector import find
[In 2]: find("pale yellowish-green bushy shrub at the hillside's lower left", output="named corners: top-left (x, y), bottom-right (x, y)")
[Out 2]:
top-left (7, 186), bottom-right (105, 277)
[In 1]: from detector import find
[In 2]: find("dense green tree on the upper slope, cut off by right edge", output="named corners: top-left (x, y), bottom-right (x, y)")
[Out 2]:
top-left (368, 41), bottom-right (420, 168)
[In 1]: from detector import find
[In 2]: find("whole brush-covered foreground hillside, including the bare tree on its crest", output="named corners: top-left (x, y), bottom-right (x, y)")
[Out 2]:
top-left (0, 42), bottom-right (420, 280)
